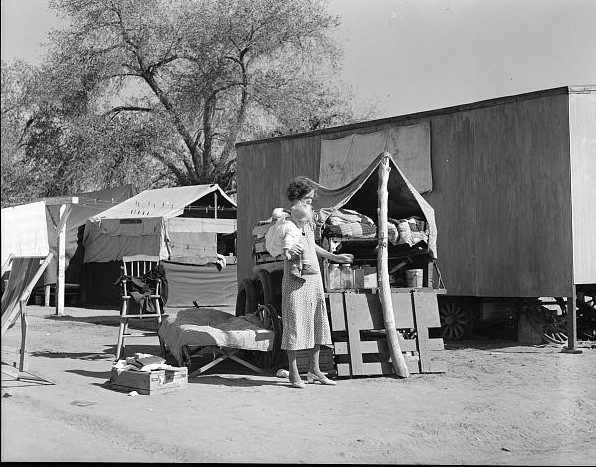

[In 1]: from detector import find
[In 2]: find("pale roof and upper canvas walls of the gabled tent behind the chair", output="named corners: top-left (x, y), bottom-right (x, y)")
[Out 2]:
top-left (83, 184), bottom-right (236, 264)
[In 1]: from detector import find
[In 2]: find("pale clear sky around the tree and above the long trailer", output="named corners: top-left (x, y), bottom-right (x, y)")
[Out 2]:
top-left (0, 0), bottom-right (596, 118)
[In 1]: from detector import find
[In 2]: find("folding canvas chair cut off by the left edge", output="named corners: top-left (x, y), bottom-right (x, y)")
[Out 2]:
top-left (1, 253), bottom-right (54, 384)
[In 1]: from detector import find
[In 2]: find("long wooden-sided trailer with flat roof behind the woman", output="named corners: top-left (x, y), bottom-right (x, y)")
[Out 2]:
top-left (237, 86), bottom-right (596, 349)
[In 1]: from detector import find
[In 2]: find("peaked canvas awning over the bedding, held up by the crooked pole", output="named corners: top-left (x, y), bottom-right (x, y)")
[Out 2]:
top-left (313, 152), bottom-right (437, 258)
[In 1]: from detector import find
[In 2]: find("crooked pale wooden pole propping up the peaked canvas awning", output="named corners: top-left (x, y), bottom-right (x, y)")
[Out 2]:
top-left (377, 153), bottom-right (410, 378)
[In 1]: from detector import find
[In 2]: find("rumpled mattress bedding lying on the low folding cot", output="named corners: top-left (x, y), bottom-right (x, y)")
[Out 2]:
top-left (158, 308), bottom-right (274, 362)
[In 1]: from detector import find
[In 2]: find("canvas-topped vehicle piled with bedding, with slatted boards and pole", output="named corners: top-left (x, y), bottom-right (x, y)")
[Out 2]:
top-left (236, 152), bottom-right (445, 377)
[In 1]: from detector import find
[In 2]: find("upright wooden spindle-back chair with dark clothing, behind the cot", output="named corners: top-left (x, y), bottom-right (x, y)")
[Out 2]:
top-left (116, 255), bottom-right (165, 361)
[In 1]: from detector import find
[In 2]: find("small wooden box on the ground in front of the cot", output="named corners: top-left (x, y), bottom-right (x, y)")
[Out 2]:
top-left (110, 367), bottom-right (188, 396)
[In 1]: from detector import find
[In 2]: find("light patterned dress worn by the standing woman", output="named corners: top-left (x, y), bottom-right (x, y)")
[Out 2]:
top-left (281, 224), bottom-right (332, 350)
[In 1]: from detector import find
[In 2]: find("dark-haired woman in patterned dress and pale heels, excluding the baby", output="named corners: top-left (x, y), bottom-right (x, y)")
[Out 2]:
top-left (281, 177), bottom-right (353, 388)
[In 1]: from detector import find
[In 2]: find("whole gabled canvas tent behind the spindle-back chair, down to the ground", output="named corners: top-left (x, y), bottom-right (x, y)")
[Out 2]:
top-left (83, 184), bottom-right (236, 306)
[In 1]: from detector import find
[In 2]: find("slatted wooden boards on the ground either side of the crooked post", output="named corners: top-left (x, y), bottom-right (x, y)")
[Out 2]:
top-left (328, 289), bottom-right (445, 376)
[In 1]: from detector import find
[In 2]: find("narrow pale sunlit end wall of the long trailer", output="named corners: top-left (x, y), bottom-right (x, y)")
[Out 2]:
top-left (569, 90), bottom-right (596, 284)
